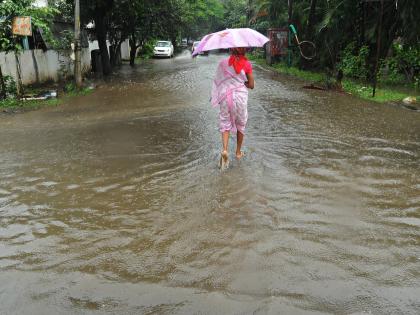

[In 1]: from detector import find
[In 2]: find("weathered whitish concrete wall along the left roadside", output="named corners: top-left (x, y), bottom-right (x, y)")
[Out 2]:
top-left (0, 48), bottom-right (91, 85)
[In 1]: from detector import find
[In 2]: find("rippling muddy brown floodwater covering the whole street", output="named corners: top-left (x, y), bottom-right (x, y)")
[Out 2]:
top-left (0, 52), bottom-right (420, 314)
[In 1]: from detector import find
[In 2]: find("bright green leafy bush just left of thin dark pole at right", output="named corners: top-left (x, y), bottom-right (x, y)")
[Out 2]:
top-left (338, 42), bottom-right (369, 80)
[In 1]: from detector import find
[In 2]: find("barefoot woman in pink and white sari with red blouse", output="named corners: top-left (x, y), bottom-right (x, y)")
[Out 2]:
top-left (211, 48), bottom-right (254, 169)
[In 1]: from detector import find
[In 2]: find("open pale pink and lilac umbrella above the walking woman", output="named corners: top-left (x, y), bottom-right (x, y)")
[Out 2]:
top-left (193, 28), bottom-right (269, 56)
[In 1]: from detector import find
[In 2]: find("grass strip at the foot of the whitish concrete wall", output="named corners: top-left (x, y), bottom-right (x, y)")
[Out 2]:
top-left (0, 84), bottom-right (92, 112)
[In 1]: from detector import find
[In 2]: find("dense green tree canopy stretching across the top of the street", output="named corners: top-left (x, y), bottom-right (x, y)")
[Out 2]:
top-left (7, 0), bottom-right (420, 82)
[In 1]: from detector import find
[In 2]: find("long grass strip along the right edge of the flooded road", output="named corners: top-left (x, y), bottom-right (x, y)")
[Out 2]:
top-left (249, 55), bottom-right (418, 103)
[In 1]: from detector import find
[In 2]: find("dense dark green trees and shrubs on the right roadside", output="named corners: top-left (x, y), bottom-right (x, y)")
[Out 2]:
top-left (253, 0), bottom-right (420, 87)
